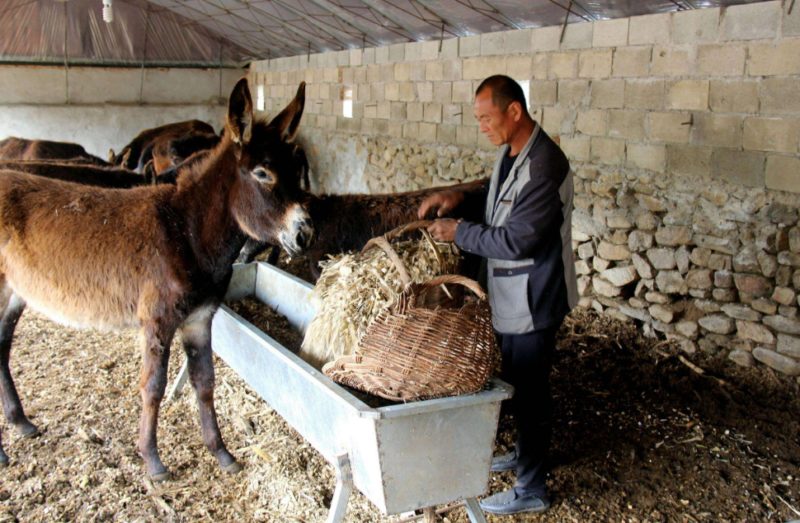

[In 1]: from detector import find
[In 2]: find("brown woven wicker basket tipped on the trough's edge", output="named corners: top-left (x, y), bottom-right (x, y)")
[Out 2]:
top-left (323, 275), bottom-right (499, 401)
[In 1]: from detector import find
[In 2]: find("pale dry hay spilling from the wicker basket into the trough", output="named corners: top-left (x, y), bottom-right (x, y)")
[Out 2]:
top-left (299, 235), bottom-right (460, 368)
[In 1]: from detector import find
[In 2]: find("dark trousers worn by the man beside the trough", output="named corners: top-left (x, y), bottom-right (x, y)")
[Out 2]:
top-left (499, 324), bottom-right (560, 495)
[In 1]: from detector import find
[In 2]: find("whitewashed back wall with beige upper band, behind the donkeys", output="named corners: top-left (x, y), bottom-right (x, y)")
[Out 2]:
top-left (0, 66), bottom-right (245, 158)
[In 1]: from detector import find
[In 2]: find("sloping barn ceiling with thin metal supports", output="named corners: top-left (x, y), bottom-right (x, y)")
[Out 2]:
top-left (0, 0), bottom-right (776, 67)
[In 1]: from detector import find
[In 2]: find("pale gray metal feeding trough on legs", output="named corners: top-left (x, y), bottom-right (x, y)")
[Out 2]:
top-left (175, 263), bottom-right (512, 523)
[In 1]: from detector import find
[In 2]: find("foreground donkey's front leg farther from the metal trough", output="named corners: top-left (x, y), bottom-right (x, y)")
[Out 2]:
top-left (139, 326), bottom-right (174, 481)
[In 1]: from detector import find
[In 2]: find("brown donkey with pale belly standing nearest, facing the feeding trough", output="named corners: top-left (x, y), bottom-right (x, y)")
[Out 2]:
top-left (0, 79), bottom-right (314, 480)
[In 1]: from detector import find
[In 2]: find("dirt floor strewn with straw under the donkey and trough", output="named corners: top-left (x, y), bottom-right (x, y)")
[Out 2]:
top-left (0, 256), bottom-right (800, 523)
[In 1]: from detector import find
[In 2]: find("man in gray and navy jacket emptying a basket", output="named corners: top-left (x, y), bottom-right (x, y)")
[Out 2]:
top-left (418, 75), bottom-right (578, 514)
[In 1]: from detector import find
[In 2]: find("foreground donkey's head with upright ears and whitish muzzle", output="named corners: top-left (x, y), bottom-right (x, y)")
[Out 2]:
top-left (225, 78), bottom-right (314, 255)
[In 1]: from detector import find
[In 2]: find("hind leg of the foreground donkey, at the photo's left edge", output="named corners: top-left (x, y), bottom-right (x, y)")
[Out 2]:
top-left (0, 288), bottom-right (39, 437)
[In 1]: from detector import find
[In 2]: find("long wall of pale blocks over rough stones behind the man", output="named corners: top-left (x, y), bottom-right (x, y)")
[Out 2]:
top-left (251, 2), bottom-right (800, 376)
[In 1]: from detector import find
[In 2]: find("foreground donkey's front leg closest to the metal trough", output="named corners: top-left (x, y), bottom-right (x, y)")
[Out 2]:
top-left (181, 307), bottom-right (242, 473)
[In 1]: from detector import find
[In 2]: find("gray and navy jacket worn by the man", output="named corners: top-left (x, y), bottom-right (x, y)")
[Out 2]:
top-left (456, 124), bottom-right (578, 334)
